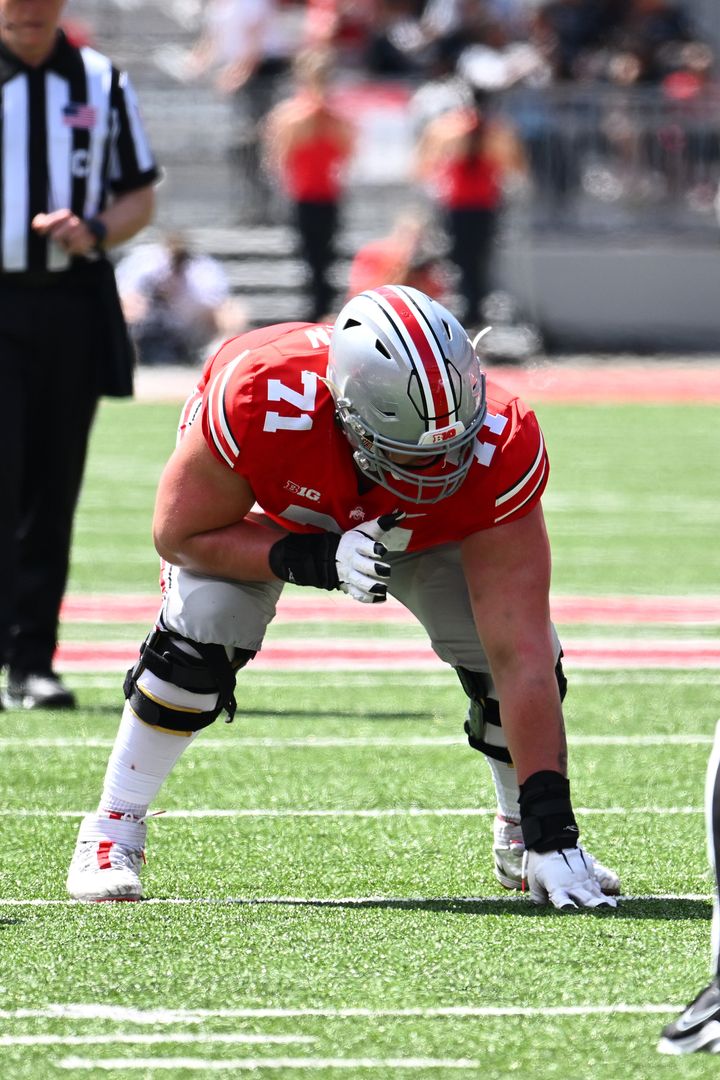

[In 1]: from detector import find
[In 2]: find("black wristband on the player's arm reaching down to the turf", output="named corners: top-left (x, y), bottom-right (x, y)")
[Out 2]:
top-left (519, 770), bottom-right (580, 852)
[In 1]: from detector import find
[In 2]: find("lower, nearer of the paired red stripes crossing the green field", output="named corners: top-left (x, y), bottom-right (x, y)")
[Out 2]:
top-left (56, 638), bottom-right (720, 672)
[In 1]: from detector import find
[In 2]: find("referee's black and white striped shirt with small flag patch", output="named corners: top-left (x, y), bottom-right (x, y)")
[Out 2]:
top-left (0, 31), bottom-right (159, 274)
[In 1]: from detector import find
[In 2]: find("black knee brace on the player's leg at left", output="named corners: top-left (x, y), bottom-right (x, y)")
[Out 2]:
top-left (123, 629), bottom-right (256, 733)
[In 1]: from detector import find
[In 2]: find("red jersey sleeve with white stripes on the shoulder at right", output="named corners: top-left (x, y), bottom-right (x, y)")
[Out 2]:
top-left (493, 409), bottom-right (549, 525)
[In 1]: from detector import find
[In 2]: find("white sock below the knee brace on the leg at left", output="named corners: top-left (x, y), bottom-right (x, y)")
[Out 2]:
top-left (99, 702), bottom-right (198, 818)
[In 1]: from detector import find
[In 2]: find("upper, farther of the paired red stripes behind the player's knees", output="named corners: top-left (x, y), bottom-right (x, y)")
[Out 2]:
top-left (63, 593), bottom-right (720, 625)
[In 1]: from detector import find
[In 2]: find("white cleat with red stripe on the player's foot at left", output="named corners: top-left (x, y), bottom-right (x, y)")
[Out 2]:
top-left (66, 813), bottom-right (147, 903)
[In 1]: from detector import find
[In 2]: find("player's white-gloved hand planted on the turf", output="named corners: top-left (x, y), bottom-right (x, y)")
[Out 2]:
top-left (522, 847), bottom-right (617, 910)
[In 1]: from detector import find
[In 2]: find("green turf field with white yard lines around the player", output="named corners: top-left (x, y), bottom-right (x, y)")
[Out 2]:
top-left (0, 393), bottom-right (720, 1080)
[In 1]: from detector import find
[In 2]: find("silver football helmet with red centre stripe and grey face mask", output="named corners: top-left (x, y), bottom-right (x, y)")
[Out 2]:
top-left (327, 285), bottom-right (486, 503)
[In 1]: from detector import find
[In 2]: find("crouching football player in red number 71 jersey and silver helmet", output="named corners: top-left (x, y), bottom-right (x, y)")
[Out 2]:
top-left (67, 285), bottom-right (620, 908)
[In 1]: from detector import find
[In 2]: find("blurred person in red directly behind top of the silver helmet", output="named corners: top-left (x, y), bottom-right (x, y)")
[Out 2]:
top-left (348, 210), bottom-right (449, 303)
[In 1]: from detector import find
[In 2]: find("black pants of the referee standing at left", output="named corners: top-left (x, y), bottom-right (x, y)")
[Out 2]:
top-left (0, 275), bottom-right (99, 674)
